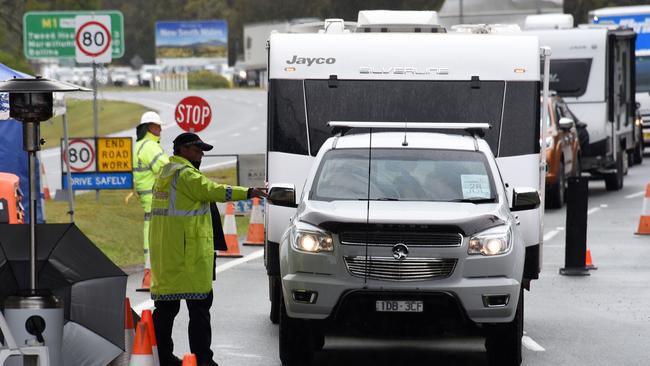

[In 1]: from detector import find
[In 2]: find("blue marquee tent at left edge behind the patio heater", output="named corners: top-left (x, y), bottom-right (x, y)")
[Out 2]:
top-left (0, 64), bottom-right (44, 223)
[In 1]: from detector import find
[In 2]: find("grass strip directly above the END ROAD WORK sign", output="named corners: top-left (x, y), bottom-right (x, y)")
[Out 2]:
top-left (41, 99), bottom-right (148, 149)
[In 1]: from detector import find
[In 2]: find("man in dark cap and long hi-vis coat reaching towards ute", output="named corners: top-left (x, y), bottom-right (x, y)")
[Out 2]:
top-left (150, 133), bottom-right (266, 366)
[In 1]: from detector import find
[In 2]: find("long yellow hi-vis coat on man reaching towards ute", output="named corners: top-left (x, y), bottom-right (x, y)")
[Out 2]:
top-left (149, 156), bottom-right (248, 300)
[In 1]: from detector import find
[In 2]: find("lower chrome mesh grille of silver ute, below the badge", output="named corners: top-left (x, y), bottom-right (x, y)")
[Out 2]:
top-left (344, 256), bottom-right (457, 281)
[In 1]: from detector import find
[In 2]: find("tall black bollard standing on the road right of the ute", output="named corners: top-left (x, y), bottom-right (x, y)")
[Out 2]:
top-left (560, 177), bottom-right (589, 276)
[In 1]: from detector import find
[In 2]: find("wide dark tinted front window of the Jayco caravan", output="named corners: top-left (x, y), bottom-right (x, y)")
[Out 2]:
top-left (268, 79), bottom-right (540, 156)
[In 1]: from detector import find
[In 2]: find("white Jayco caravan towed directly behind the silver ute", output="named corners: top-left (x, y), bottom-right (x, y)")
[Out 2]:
top-left (265, 12), bottom-right (546, 334)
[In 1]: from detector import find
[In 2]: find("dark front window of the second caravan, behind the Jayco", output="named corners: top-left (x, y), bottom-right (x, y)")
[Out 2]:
top-left (542, 58), bottom-right (592, 97)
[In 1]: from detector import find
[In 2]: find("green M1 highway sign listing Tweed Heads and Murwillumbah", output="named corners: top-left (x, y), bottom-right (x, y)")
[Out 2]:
top-left (23, 10), bottom-right (124, 59)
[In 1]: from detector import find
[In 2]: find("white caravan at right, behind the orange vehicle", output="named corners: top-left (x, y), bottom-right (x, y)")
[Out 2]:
top-left (524, 14), bottom-right (642, 190)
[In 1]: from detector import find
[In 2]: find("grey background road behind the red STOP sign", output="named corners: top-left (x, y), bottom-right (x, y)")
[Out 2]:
top-left (41, 89), bottom-right (266, 193)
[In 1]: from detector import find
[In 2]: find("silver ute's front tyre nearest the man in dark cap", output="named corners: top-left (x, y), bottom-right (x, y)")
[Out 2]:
top-left (278, 301), bottom-right (314, 366)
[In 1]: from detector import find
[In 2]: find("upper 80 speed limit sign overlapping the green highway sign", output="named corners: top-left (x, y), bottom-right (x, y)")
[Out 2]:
top-left (75, 15), bottom-right (113, 64)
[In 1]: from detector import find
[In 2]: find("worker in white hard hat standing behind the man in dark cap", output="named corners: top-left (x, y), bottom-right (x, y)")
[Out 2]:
top-left (133, 111), bottom-right (169, 291)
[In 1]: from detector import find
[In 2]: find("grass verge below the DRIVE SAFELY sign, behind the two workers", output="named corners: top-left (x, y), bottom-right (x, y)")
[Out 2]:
top-left (45, 168), bottom-right (249, 267)
